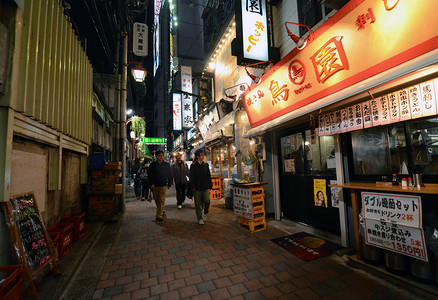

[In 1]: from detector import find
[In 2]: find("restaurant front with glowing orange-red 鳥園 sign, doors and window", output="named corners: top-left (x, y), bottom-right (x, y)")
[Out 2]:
top-left (238, 0), bottom-right (438, 284)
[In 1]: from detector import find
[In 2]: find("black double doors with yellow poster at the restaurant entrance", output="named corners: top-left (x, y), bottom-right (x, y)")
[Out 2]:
top-left (277, 125), bottom-right (340, 233)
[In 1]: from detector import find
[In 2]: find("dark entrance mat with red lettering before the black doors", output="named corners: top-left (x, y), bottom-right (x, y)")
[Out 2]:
top-left (271, 232), bottom-right (342, 261)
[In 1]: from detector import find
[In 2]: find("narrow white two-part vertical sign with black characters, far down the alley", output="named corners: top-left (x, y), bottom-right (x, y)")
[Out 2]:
top-left (181, 66), bottom-right (193, 128)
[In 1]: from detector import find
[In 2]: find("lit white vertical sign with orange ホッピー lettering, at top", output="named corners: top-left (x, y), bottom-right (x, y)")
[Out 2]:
top-left (241, 0), bottom-right (269, 61)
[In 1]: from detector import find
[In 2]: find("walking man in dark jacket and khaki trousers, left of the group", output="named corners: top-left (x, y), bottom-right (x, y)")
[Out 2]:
top-left (149, 150), bottom-right (172, 222)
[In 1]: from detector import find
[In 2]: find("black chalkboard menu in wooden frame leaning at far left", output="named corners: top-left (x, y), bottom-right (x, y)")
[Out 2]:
top-left (2, 193), bottom-right (60, 298)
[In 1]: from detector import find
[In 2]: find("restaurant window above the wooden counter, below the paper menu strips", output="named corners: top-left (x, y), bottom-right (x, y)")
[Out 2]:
top-left (351, 117), bottom-right (438, 175)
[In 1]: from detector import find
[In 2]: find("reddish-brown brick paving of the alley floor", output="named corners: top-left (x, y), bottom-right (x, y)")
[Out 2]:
top-left (63, 189), bottom-right (420, 300)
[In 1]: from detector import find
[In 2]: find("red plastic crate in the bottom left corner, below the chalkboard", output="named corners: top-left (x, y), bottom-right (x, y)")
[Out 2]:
top-left (0, 265), bottom-right (23, 300)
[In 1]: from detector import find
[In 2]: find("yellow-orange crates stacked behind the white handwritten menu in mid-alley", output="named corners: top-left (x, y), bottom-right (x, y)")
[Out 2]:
top-left (237, 185), bottom-right (266, 233)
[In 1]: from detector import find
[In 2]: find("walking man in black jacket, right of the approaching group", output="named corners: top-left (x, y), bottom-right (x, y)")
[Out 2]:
top-left (189, 149), bottom-right (213, 225)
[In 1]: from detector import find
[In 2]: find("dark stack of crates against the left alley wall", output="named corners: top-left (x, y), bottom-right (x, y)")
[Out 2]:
top-left (88, 162), bottom-right (123, 221)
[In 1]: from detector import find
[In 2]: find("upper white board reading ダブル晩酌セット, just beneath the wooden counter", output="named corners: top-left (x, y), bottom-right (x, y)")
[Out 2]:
top-left (362, 192), bottom-right (422, 228)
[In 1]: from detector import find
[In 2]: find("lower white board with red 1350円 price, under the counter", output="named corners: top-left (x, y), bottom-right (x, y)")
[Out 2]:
top-left (365, 219), bottom-right (428, 261)
